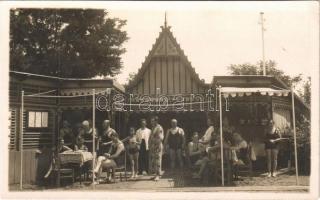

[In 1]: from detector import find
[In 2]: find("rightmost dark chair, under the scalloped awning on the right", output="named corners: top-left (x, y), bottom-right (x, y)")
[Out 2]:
top-left (232, 143), bottom-right (252, 180)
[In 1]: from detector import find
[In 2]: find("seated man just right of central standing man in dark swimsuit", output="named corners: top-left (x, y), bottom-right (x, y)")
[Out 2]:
top-left (187, 132), bottom-right (205, 167)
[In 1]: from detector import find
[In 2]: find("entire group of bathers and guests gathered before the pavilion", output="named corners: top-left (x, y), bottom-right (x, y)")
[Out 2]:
top-left (59, 116), bottom-right (281, 184)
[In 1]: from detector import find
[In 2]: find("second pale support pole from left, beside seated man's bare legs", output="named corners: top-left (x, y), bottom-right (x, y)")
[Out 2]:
top-left (92, 89), bottom-right (96, 188)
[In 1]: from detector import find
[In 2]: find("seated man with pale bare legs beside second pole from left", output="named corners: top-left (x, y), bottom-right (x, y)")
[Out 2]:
top-left (94, 132), bottom-right (125, 181)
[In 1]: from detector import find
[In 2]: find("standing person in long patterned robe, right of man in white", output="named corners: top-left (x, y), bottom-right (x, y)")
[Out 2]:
top-left (149, 116), bottom-right (164, 181)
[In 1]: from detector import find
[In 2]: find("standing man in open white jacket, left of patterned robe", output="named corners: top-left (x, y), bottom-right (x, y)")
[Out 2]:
top-left (136, 119), bottom-right (151, 175)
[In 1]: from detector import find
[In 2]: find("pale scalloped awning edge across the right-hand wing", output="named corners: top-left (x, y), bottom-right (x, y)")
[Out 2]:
top-left (220, 87), bottom-right (290, 98)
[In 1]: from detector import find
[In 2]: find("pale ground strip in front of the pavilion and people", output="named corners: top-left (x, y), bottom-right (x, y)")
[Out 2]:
top-left (10, 170), bottom-right (309, 192)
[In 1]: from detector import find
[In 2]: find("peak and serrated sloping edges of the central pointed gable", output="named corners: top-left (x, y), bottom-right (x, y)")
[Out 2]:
top-left (127, 21), bottom-right (207, 88)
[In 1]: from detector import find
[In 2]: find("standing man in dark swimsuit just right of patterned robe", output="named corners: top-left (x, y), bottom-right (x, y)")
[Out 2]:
top-left (164, 119), bottom-right (185, 170)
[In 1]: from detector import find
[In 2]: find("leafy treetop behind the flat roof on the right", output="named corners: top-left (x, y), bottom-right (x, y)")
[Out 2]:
top-left (228, 60), bottom-right (302, 86)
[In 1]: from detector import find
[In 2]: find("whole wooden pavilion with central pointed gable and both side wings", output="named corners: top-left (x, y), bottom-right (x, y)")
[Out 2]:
top-left (9, 18), bottom-right (310, 184)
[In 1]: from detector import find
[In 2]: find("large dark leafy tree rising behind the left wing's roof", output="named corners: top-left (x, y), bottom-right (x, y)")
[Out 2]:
top-left (10, 9), bottom-right (128, 78)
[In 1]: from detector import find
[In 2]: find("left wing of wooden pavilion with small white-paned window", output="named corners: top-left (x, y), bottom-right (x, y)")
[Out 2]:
top-left (9, 71), bottom-right (124, 184)
